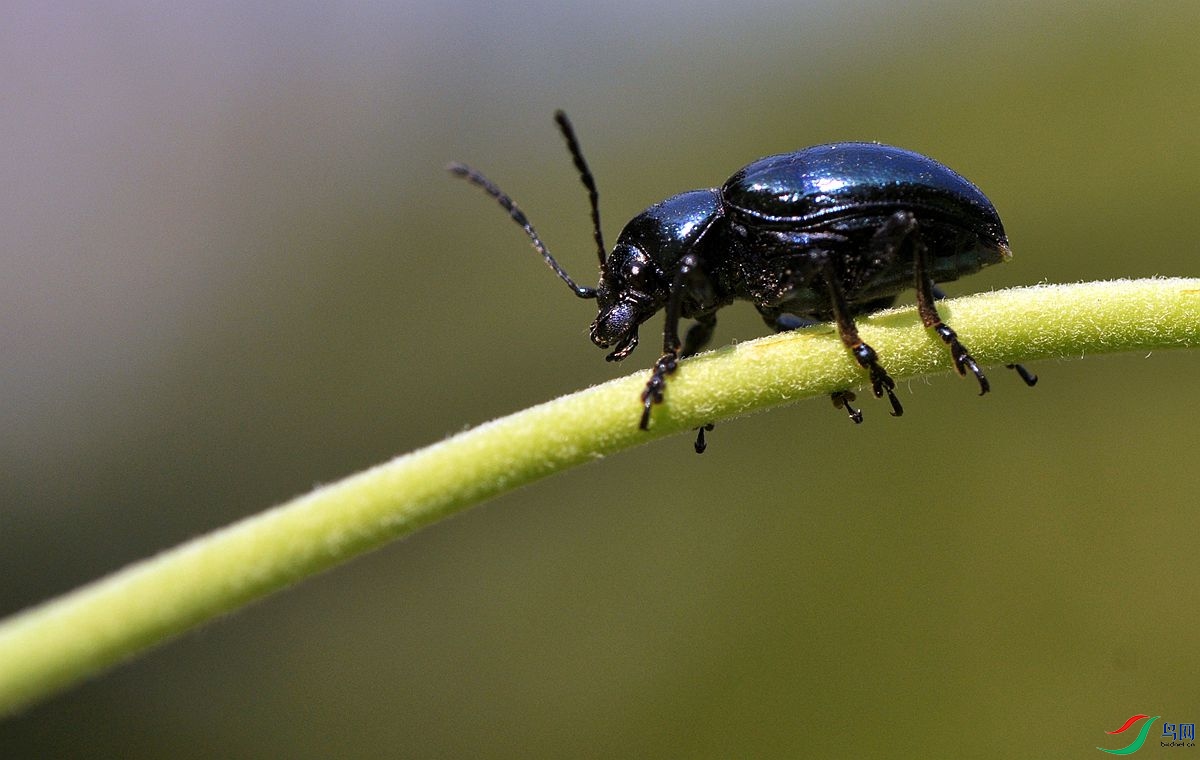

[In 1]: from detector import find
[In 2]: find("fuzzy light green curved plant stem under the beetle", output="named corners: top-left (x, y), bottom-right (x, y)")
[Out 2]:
top-left (0, 279), bottom-right (1200, 714)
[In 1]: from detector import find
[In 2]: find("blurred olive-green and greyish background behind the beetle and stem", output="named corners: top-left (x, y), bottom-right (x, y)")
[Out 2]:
top-left (0, 0), bottom-right (1200, 758)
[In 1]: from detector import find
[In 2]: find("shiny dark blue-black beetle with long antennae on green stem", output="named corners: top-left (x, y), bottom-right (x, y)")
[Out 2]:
top-left (448, 110), bottom-right (1037, 453)
